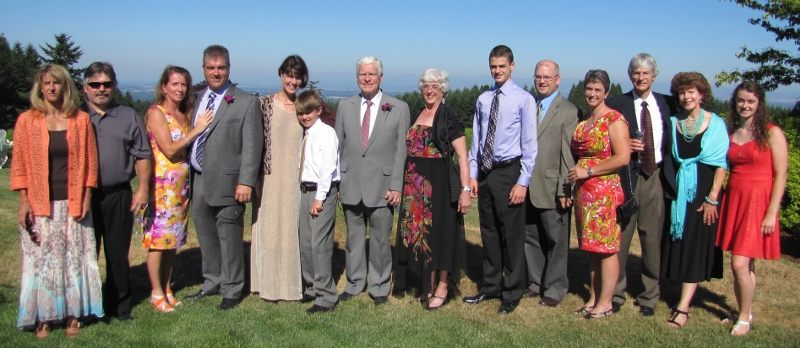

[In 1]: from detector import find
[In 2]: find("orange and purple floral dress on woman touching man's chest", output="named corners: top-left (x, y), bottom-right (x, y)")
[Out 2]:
top-left (142, 105), bottom-right (189, 250)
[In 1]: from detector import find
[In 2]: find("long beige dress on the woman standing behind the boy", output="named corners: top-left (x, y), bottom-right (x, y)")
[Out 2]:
top-left (250, 102), bottom-right (303, 301)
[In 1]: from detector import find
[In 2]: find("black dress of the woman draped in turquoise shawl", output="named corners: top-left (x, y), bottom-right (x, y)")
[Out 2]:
top-left (661, 131), bottom-right (722, 283)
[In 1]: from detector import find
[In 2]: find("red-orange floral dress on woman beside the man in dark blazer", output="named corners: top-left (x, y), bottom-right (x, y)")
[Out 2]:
top-left (571, 111), bottom-right (627, 253)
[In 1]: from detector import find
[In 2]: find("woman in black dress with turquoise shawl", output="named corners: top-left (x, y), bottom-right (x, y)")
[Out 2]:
top-left (661, 72), bottom-right (728, 327)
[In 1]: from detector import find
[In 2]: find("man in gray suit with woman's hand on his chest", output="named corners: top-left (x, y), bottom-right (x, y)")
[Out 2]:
top-left (186, 45), bottom-right (264, 310)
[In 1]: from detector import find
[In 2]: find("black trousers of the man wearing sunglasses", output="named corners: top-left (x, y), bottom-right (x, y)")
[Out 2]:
top-left (92, 183), bottom-right (133, 316)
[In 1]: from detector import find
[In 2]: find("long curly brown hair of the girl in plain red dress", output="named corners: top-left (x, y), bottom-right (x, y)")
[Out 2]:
top-left (728, 81), bottom-right (772, 150)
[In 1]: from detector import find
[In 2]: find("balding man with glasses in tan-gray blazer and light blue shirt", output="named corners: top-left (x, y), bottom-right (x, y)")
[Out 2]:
top-left (523, 60), bottom-right (581, 307)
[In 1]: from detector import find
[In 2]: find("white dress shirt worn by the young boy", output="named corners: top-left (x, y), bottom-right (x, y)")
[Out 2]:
top-left (300, 119), bottom-right (341, 202)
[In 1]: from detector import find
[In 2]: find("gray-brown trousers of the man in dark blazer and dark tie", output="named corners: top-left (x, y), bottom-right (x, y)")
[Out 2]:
top-left (613, 168), bottom-right (666, 308)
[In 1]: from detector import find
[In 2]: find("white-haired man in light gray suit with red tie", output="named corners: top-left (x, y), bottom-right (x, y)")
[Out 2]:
top-left (336, 56), bottom-right (411, 306)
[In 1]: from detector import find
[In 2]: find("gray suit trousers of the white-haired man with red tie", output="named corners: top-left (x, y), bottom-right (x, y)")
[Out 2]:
top-left (342, 202), bottom-right (394, 297)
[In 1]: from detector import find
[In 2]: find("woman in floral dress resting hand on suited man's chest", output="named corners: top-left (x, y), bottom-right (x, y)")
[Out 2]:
top-left (142, 66), bottom-right (212, 312)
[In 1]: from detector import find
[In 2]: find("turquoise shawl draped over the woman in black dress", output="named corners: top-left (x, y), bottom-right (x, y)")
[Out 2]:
top-left (669, 113), bottom-right (729, 241)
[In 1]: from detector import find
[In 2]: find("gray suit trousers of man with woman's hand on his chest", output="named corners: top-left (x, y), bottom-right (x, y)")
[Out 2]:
top-left (192, 172), bottom-right (245, 299)
